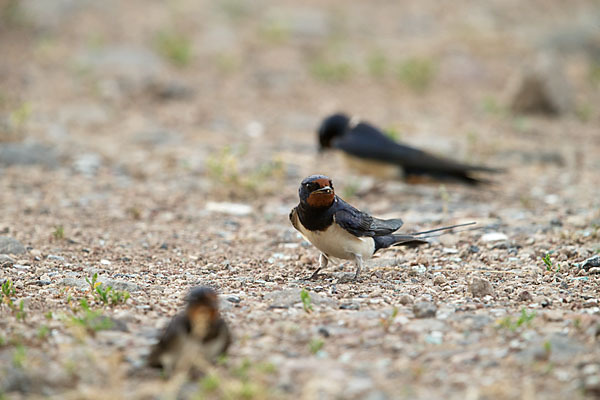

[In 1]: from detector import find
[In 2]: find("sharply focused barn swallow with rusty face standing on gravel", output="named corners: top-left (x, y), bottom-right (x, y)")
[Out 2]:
top-left (290, 175), bottom-right (474, 280)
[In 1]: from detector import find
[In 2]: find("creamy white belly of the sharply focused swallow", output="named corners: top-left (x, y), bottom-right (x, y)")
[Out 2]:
top-left (298, 219), bottom-right (375, 260)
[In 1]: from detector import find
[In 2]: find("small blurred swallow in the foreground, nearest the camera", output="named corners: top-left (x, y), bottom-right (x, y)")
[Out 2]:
top-left (148, 287), bottom-right (231, 375)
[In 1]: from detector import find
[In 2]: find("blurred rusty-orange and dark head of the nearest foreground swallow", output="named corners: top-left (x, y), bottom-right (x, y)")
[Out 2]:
top-left (186, 287), bottom-right (219, 336)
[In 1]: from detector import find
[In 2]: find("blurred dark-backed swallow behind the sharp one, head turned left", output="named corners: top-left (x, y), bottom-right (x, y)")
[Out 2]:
top-left (318, 113), bottom-right (502, 184)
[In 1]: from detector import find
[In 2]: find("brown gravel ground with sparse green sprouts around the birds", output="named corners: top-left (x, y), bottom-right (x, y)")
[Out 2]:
top-left (0, 0), bottom-right (600, 400)
